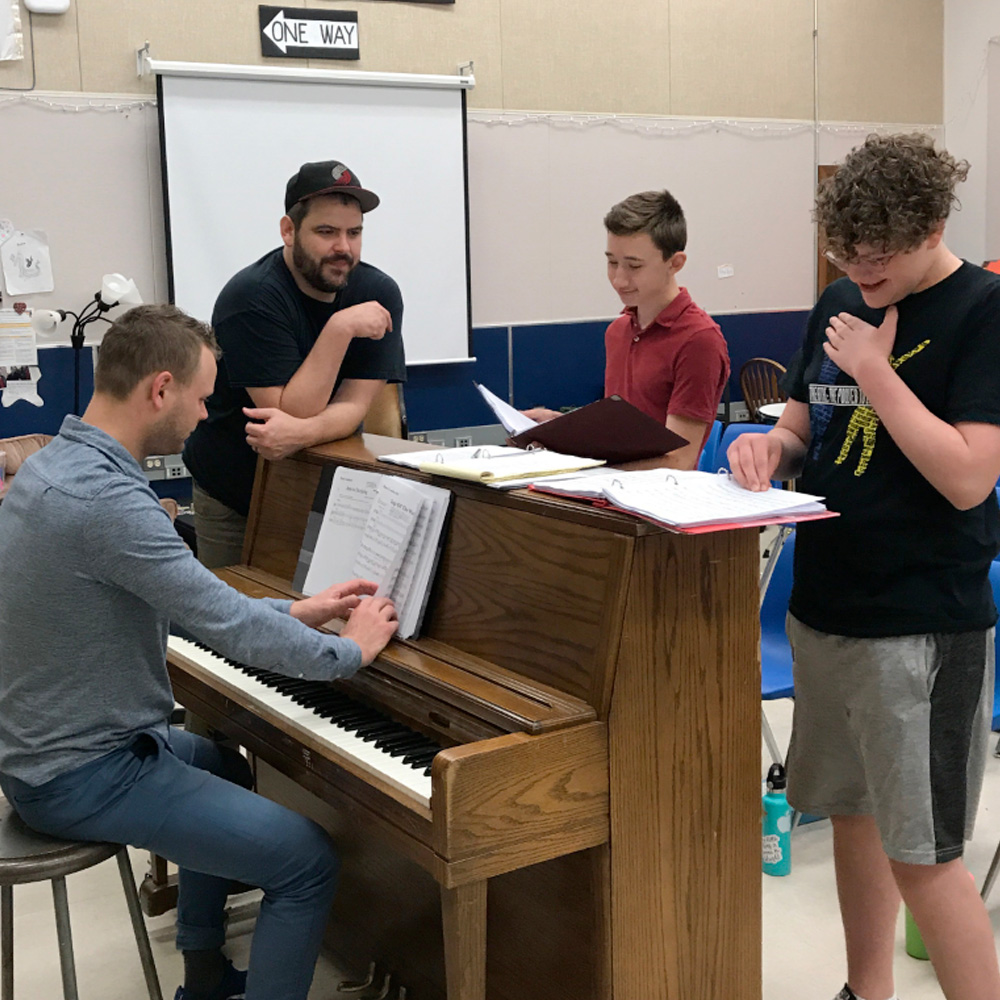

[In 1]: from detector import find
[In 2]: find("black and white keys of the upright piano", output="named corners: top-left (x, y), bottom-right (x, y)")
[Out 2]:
top-left (167, 635), bottom-right (441, 808)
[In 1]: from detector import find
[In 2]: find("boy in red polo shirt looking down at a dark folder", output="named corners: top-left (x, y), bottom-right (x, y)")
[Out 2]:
top-left (526, 191), bottom-right (729, 469)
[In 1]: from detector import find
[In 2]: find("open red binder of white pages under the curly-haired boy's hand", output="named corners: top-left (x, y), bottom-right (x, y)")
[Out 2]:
top-left (532, 469), bottom-right (832, 530)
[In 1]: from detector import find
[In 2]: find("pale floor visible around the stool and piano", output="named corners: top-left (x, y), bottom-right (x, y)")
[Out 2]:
top-left (14, 702), bottom-right (1000, 1000)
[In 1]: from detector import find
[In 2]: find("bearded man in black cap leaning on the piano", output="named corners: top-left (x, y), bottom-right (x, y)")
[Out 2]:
top-left (184, 160), bottom-right (406, 567)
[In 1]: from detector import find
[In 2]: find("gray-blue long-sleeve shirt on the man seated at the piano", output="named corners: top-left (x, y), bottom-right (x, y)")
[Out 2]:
top-left (0, 416), bottom-right (361, 785)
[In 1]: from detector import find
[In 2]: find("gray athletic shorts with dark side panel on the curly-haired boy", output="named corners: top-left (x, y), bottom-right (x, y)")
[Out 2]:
top-left (786, 615), bottom-right (994, 864)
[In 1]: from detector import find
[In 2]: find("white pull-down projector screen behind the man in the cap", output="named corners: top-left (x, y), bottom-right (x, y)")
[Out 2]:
top-left (153, 64), bottom-right (470, 364)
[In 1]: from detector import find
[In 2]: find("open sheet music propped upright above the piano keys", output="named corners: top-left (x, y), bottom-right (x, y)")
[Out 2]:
top-left (294, 466), bottom-right (451, 639)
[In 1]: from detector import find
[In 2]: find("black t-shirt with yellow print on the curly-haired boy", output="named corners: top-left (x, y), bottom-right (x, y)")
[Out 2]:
top-left (785, 263), bottom-right (1000, 637)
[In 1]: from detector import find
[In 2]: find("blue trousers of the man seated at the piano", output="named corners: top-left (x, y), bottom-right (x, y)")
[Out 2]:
top-left (0, 729), bottom-right (339, 1000)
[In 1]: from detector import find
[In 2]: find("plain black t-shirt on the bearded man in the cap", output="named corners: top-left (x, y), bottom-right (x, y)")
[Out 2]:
top-left (184, 248), bottom-right (406, 515)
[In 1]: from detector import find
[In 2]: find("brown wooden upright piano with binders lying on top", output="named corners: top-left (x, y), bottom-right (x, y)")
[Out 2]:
top-left (169, 435), bottom-right (761, 1000)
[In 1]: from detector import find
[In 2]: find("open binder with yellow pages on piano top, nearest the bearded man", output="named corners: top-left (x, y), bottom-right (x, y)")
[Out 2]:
top-left (379, 445), bottom-right (604, 484)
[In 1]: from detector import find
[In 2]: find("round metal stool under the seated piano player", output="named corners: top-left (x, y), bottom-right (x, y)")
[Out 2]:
top-left (0, 800), bottom-right (163, 1000)
